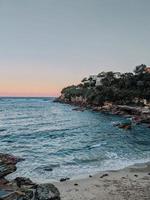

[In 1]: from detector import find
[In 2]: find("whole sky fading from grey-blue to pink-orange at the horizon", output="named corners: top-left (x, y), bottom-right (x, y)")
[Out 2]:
top-left (0, 0), bottom-right (150, 96)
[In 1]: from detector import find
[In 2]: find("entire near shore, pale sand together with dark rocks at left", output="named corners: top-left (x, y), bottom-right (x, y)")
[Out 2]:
top-left (0, 154), bottom-right (150, 200)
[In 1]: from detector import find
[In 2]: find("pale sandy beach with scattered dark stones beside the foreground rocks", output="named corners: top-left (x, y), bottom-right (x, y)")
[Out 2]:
top-left (53, 162), bottom-right (150, 200)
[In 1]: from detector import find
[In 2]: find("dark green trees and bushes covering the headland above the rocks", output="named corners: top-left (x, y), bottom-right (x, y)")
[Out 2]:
top-left (61, 64), bottom-right (150, 105)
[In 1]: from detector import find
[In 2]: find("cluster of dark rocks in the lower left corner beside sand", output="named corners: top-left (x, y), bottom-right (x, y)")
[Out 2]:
top-left (0, 153), bottom-right (60, 200)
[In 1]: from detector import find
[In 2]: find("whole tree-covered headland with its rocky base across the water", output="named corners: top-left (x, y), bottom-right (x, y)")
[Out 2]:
top-left (55, 64), bottom-right (150, 128)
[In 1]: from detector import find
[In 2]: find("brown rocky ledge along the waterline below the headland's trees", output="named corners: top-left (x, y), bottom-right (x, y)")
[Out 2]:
top-left (54, 96), bottom-right (150, 128)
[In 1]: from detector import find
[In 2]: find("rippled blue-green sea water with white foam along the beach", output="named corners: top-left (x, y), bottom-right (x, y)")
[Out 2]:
top-left (0, 98), bottom-right (150, 182)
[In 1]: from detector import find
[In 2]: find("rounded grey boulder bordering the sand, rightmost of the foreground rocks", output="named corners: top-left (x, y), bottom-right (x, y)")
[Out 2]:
top-left (35, 184), bottom-right (60, 200)
